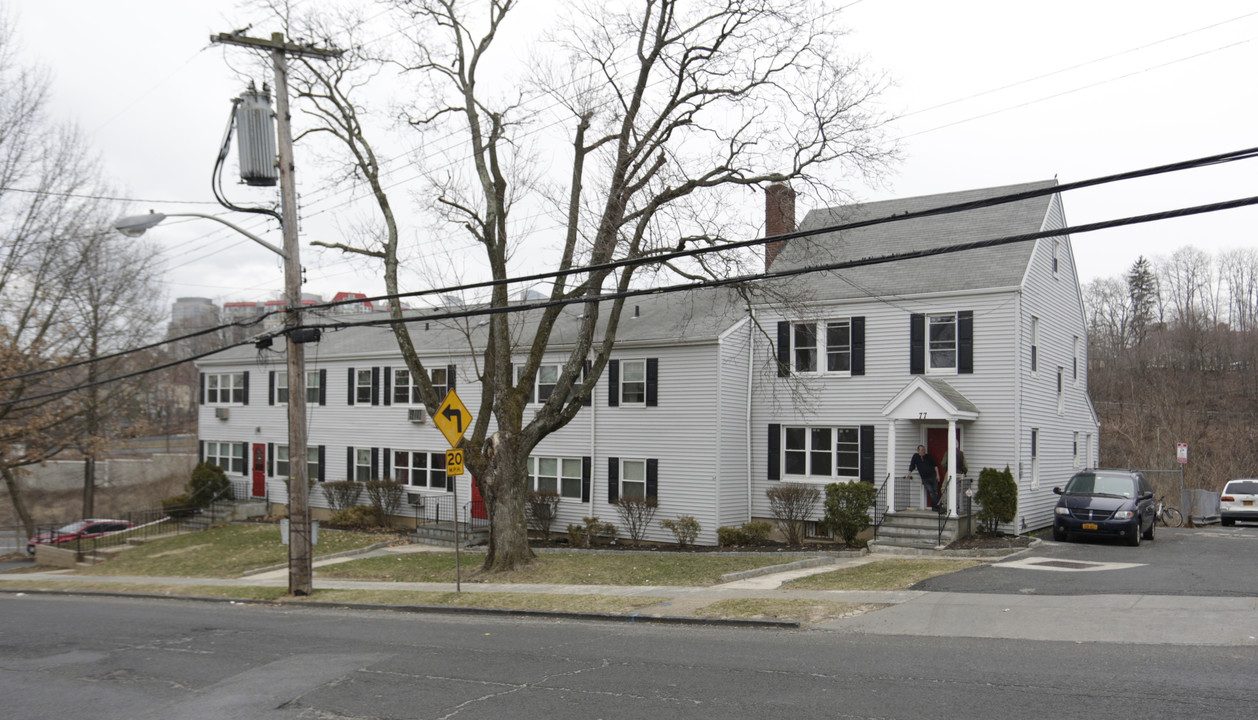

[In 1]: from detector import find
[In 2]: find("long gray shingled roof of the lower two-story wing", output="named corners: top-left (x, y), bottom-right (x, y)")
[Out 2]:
top-left (197, 288), bottom-right (746, 363)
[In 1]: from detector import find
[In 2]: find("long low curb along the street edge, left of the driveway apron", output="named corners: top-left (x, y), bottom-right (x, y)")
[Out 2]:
top-left (0, 588), bottom-right (800, 629)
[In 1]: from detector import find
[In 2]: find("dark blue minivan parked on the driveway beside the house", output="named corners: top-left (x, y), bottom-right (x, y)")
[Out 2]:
top-left (1053, 470), bottom-right (1156, 545)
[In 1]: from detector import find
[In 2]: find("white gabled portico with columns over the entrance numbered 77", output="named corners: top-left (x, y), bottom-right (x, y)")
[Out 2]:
top-left (882, 376), bottom-right (979, 517)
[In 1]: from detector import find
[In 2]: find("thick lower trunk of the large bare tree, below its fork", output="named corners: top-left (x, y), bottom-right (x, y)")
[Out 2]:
top-left (481, 437), bottom-right (535, 573)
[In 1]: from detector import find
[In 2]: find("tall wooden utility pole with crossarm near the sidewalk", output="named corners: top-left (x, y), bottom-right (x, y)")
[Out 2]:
top-left (210, 33), bottom-right (341, 595)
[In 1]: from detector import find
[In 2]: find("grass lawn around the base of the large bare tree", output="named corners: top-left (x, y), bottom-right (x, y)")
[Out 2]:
top-left (315, 553), bottom-right (782, 585)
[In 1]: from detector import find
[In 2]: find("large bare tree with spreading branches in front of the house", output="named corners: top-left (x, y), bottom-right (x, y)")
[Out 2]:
top-left (273, 0), bottom-right (889, 570)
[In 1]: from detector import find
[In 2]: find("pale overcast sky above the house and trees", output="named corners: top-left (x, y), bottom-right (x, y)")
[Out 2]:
top-left (6, 0), bottom-right (1258, 312)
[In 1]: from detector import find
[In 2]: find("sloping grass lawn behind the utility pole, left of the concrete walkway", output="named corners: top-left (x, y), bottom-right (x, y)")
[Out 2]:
top-left (81, 524), bottom-right (389, 578)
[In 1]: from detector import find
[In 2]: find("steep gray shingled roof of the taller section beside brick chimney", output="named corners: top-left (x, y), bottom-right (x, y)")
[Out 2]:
top-left (770, 180), bottom-right (1057, 300)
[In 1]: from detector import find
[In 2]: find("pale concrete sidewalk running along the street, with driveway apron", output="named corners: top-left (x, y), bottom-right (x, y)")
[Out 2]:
top-left (0, 546), bottom-right (1258, 646)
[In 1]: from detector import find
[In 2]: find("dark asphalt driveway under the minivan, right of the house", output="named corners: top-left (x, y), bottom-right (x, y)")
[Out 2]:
top-left (913, 525), bottom-right (1258, 597)
